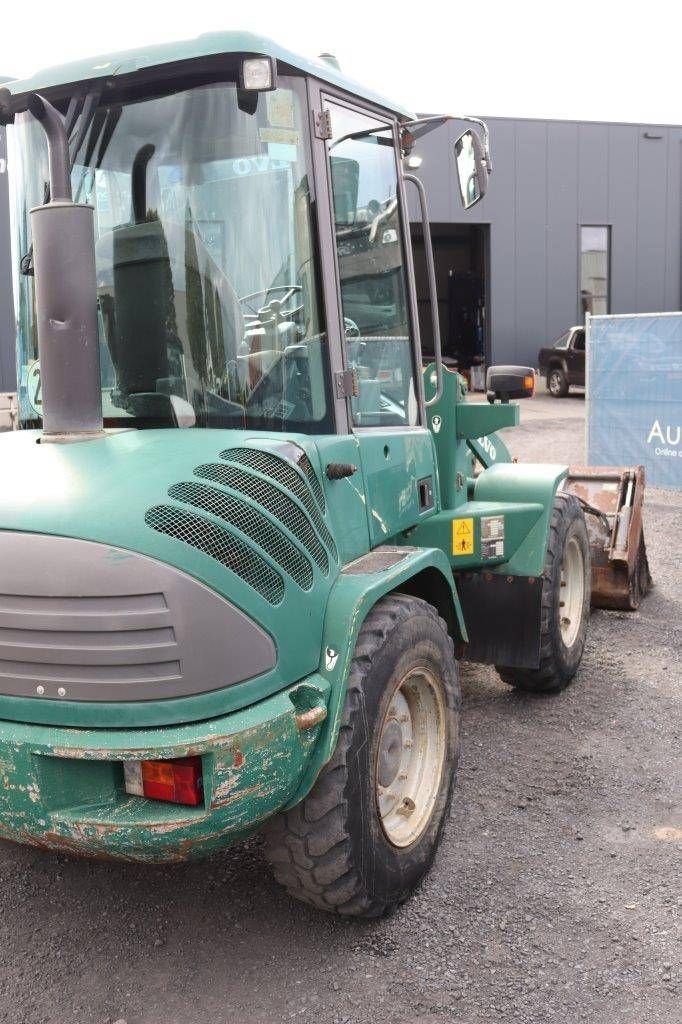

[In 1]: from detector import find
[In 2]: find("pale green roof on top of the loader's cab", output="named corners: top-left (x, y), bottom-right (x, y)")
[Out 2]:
top-left (6, 32), bottom-right (413, 117)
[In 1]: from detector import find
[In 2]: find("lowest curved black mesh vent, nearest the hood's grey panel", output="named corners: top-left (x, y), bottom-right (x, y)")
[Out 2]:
top-left (144, 505), bottom-right (285, 604)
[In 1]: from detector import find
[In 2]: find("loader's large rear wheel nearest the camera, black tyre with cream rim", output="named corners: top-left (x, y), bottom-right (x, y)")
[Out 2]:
top-left (265, 594), bottom-right (460, 918)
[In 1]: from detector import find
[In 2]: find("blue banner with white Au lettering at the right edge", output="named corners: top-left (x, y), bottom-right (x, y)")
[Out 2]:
top-left (587, 313), bottom-right (682, 489)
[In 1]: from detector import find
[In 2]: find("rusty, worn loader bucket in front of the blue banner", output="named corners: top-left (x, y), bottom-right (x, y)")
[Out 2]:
top-left (564, 466), bottom-right (652, 611)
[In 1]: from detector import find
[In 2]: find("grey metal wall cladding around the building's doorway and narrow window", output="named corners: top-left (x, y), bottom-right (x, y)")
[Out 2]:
top-left (412, 118), bottom-right (682, 365)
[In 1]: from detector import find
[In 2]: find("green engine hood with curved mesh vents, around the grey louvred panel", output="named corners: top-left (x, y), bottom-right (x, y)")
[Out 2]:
top-left (0, 429), bottom-right (339, 724)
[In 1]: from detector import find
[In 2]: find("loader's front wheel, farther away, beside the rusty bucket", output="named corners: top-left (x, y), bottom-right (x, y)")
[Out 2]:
top-left (496, 494), bottom-right (592, 693)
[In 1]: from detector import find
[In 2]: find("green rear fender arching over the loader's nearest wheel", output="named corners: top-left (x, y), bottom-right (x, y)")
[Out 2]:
top-left (280, 547), bottom-right (468, 808)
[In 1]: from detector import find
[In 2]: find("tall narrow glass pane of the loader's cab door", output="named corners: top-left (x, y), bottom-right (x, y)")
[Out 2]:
top-left (328, 104), bottom-right (419, 426)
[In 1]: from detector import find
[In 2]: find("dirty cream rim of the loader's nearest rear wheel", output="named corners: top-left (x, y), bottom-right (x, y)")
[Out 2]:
top-left (375, 668), bottom-right (445, 847)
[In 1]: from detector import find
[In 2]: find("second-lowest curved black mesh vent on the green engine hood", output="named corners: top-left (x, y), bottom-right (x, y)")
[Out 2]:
top-left (168, 481), bottom-right (312, 590)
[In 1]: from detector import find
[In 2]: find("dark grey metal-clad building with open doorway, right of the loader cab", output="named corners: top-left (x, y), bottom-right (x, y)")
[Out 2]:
top-left (413, 118), bottom-right (682, 367)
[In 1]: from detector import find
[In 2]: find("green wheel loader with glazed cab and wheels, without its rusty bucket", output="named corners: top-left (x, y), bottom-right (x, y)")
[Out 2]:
top-left (0, 34), bottom-right (638, 915)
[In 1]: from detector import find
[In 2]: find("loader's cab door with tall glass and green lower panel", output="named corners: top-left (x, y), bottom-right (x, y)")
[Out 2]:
top-left (324, 97), bottom-right (435, 547)
